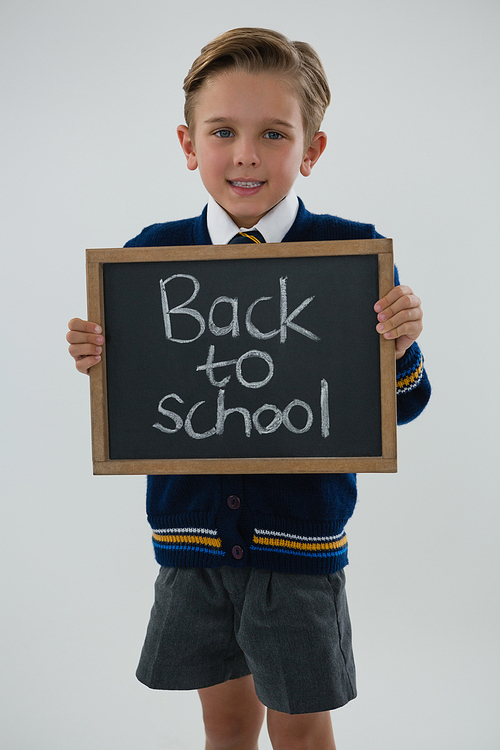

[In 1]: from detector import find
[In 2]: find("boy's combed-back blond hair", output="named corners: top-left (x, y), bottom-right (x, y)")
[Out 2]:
top-left (183, 28), bottom-right (331, 147)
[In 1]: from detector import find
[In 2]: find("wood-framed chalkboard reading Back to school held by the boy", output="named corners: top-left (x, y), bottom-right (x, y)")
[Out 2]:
top-left (87, 240), bottom-right (396, 474)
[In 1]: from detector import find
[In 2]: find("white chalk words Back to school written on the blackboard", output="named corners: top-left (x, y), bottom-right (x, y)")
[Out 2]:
top-left (153, 273), bottom-right (330, 440)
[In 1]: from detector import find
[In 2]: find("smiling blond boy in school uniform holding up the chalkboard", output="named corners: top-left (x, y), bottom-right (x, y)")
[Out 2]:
top-left (67, 28), bottom-right (430, 750)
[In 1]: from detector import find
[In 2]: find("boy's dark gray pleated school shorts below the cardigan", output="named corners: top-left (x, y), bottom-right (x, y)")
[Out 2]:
top-left (137, 567), bottom-right (356, 714)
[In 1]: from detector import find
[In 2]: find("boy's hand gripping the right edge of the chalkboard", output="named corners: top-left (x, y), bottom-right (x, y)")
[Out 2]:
top-left (374, 286), bottom-right (423, 359)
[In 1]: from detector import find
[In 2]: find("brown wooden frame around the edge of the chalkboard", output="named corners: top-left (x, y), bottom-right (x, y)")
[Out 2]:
top-left (86, 239), bottom-right (397, 474)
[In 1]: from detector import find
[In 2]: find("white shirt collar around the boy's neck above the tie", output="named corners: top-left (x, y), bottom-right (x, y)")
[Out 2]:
top-left (207, 190), bottom-right (299, 245)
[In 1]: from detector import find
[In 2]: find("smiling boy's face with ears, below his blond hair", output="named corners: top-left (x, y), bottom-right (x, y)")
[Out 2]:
top-left (177, 71), bottom-right (326, 228)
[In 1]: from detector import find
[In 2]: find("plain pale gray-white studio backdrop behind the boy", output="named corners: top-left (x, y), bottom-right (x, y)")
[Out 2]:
top-left (0, 0), bottom-right (500, 750)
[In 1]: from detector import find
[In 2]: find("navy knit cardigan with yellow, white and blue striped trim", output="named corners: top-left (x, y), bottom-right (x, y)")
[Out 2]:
top-left (126, 200), bottom-right (430, 574)
